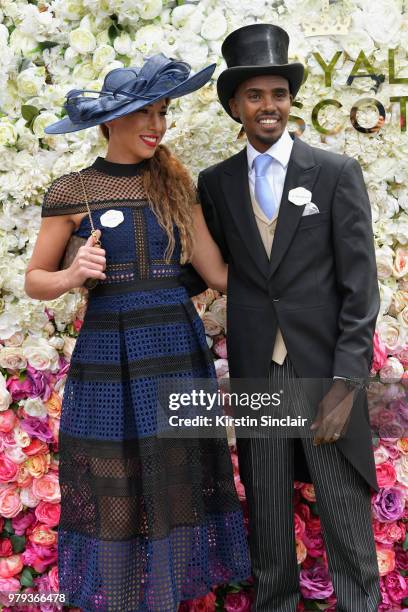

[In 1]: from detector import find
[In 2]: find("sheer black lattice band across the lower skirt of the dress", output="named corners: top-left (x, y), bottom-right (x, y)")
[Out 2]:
top-left (59, 431), bottom-right (240, 540)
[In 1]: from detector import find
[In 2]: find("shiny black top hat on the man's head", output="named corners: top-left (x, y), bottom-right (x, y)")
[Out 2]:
top-left (217, 23), bottom-right (304, 122)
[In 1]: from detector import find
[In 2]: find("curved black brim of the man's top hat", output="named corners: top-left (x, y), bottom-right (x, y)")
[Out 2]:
top-left (217, 62), bottom-right (305, 123)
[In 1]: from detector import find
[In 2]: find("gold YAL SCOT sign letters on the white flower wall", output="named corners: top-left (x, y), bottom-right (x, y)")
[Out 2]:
top-left (290, 49), bottom-right (408, 135)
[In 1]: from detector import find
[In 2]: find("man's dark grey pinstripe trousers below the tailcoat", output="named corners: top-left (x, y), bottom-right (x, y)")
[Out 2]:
top-left (238, 358), bottom-right (381, 612)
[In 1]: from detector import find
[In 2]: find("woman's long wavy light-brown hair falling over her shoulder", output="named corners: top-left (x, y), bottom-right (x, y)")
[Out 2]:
top-left (100, 124), bottom-right (197, 264)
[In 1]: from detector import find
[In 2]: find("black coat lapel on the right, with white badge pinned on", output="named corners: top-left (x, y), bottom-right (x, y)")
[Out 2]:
top-left (268, 138), bottom-right (320, 276)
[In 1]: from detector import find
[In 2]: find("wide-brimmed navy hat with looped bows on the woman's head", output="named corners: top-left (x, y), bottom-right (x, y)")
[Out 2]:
top-left (45, 53), bottom-right (216, 134)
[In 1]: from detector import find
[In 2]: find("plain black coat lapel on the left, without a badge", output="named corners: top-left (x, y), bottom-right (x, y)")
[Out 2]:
top-left (222, 149), bottom-right (269, 277)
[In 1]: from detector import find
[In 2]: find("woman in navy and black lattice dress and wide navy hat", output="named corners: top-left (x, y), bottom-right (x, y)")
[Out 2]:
top-left (26, 54), bottom-right (250, 612)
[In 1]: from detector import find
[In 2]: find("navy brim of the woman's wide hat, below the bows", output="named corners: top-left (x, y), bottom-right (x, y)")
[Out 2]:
top-left (44, 64), bottom-right (216, 134)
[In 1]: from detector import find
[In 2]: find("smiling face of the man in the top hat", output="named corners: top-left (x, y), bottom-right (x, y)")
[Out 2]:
top-left (229, 75), bottom-right (293, 153)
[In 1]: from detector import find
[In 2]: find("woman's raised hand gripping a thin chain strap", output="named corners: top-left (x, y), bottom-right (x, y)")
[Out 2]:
top-left (64, 230), bottom-right (106, 290)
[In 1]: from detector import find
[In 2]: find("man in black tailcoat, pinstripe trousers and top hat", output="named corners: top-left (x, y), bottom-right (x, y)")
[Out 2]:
top-left (198, 24), bottom-right (380, 612)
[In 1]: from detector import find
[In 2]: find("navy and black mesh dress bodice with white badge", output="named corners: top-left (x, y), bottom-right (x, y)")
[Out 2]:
top-left (42, 157), bottom-right (181, 285)
